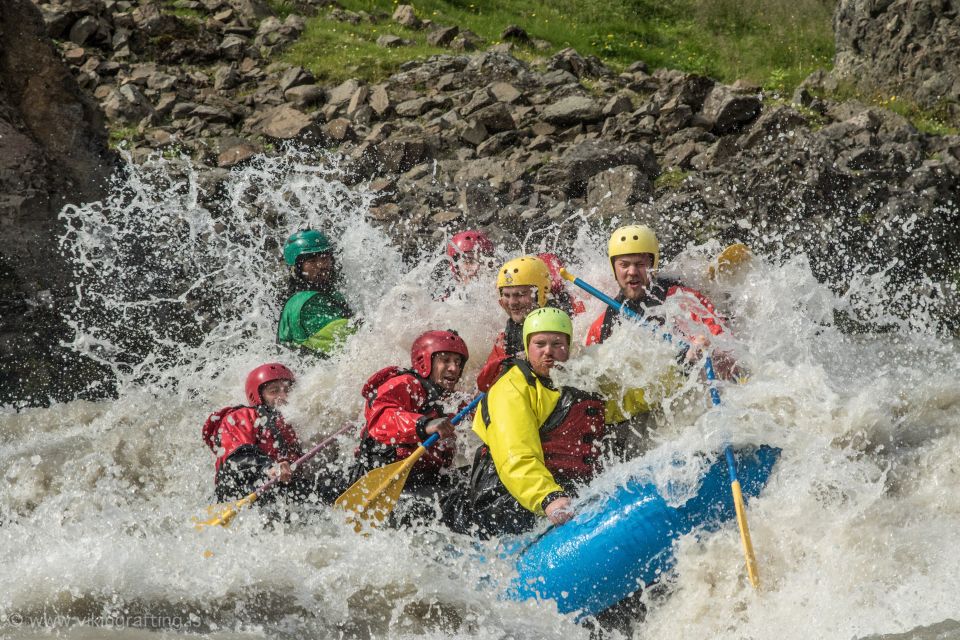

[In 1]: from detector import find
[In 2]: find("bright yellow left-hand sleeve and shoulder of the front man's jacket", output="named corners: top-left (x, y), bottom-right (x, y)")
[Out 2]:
top-left (473, 366), bottom-right (563, 515)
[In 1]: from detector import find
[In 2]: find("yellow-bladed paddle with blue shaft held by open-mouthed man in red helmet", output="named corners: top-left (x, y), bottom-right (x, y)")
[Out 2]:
top-left (334, 393), bottom-right (485, 533)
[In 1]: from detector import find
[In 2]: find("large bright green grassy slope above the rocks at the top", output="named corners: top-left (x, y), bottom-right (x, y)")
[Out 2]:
top-left (274, 0), bottom-right (835, 92)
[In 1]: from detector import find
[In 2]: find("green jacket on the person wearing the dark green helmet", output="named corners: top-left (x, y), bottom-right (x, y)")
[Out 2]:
top-left (277, 291), bottom-right (356, 355)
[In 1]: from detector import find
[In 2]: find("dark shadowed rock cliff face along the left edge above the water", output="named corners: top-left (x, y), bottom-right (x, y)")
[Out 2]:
top-left (0, 0), bottom-right (113, 404)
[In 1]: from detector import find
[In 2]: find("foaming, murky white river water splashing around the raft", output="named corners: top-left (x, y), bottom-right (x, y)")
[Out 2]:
top-left (0, 155), bottom-right (960, 640)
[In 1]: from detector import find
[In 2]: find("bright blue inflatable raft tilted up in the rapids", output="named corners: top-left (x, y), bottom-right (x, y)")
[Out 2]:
top-left (510, 446), bottom-right (780, 617)
